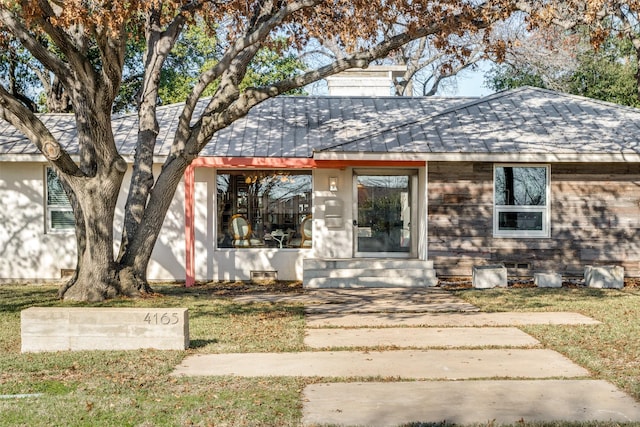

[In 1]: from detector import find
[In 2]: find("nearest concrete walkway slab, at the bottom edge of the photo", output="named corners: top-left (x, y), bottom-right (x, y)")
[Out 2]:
top-left (302, 380), bottom-right (640, 427)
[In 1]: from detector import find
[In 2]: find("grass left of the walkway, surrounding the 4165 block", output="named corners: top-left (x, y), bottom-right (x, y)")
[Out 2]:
top-left (0, 285), bottom-right (304, 426)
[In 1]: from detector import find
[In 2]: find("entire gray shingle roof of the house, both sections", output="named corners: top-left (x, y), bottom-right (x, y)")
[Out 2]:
top-left (0, 87), bottom-right (640, 158)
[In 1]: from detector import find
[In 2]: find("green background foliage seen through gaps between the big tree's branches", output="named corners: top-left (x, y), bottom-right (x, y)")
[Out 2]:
top-left (0, 23), bottom-right (305, 113)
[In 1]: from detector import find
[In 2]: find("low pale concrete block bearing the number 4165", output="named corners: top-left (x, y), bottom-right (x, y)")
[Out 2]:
top-left (20, 307), bottom-right (189, 353)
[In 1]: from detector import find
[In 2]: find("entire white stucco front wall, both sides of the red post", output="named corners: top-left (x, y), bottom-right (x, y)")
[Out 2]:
top-left (0, 162), bottom-right (427, 281)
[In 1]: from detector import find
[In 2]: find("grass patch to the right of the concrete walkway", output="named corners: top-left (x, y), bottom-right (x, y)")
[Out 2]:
top-left (456, 288), bottom-right (640, 400)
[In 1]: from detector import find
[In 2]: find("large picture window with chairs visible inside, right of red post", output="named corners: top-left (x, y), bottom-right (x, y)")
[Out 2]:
top-left (216, 170), bottom-right (312, 248)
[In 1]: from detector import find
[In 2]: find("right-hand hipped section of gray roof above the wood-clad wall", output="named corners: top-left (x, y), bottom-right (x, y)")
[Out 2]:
top-left (324, 87), bottom-right (640, 154)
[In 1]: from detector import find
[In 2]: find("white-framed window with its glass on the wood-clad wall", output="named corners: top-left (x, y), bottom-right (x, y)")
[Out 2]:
top-left (493, 165), bottom-right (550, 237)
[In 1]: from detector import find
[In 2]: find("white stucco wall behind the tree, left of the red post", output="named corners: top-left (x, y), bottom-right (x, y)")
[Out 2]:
top-left (0, 162), bottom-right (185, 282)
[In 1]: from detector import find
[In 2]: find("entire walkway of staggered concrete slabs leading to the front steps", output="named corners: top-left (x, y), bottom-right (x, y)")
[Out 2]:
top-left (174, 289), bottom-right (640, 426)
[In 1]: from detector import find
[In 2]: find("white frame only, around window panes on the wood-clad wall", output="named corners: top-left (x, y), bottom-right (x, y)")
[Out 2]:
top-left (492, 163), bottom-right (551, 239)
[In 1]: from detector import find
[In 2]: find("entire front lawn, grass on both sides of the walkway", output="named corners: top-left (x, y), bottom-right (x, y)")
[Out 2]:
top-left (0, 285), bottom-right (640, 426)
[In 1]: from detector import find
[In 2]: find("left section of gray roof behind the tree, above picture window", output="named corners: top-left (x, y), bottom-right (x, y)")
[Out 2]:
top-left (0, 97), bottom-right (468, 157)
